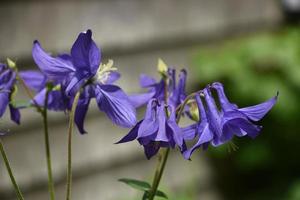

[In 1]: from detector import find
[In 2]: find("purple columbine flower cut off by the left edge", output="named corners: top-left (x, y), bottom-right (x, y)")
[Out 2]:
top-left (0, 63), bottom-right (21, 124)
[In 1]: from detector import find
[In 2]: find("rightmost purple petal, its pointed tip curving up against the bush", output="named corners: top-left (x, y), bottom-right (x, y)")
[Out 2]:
top-left (239, 93), bottom-right (278, 121)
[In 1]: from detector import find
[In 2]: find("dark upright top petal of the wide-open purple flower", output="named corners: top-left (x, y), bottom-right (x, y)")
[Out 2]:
top-left (71, 30), bottom-right (101, 74)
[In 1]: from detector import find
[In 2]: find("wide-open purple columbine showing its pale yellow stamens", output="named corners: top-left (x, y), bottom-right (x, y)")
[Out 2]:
top-left (32, 30), bottom-right (136, 133)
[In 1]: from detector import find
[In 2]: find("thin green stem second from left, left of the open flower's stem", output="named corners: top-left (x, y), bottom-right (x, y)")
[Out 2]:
top-left (42, 88), bottom-right (55, 200)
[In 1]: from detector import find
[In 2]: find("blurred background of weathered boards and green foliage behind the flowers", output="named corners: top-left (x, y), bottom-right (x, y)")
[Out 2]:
top-left (0, 0), bottom-right (300, 200)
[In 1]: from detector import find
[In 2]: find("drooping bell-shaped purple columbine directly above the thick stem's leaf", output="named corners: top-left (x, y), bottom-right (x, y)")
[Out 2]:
top-left (118, 99), bottom-right (184, 159)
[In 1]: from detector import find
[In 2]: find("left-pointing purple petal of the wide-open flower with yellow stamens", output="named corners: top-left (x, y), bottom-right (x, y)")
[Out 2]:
top-left (32, 41), bottom-right (74, 80)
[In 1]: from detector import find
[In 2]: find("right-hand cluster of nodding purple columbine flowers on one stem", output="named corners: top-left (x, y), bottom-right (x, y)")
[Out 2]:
top-left (118, 62), bottom-right (278, 159)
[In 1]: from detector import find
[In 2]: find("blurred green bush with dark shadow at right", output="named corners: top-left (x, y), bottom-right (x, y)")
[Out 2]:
top-left (192, 27), bottom-right (300, 200)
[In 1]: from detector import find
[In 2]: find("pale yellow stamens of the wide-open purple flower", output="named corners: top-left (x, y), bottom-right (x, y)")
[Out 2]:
top-left (93, 60), bottom-right (118, 84)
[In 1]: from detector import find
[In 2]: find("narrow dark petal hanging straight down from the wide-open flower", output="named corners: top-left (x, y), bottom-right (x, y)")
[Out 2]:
top-left (74, 97), bottom-right (90, 134)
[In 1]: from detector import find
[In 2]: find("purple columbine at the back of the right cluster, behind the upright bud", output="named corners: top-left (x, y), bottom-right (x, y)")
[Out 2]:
top-left (130, 68), bottom-right (187, 108)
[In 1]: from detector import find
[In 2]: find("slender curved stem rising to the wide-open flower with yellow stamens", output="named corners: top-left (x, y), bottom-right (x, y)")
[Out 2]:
top-left (66, 91), bottom-right (80, 200)
